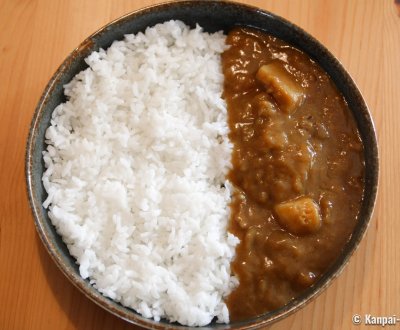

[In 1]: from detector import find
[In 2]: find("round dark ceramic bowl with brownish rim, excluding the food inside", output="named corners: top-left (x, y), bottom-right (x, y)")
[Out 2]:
top-left (26, 1), bottom-right (378, 329)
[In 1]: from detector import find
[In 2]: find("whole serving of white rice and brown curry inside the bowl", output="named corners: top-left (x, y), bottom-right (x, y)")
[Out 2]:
top-left (43, 21), bottom-right (364, 326)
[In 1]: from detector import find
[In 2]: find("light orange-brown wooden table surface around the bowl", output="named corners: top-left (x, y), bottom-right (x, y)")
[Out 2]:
top-left (0, 0), bottom-right (400, 329)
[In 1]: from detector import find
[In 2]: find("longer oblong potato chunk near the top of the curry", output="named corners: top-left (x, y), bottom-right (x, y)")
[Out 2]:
top-left (256, 61), bottom-right (305, 114)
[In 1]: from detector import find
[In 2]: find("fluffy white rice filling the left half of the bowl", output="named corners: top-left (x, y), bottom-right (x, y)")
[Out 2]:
top-left (43, 21), bottom-right (238, 326)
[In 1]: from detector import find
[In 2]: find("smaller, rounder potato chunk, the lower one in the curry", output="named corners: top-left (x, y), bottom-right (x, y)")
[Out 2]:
top-left (275, 197), bottom-right (321, 235)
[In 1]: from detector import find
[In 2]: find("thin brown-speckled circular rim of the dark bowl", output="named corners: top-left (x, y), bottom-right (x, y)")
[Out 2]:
top-left (25, 0), bottom-right (379, 330)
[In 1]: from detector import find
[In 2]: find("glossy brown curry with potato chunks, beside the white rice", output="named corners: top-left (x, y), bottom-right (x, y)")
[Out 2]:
top-left (222, 28), bottom-right (364, 321)
